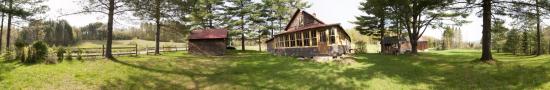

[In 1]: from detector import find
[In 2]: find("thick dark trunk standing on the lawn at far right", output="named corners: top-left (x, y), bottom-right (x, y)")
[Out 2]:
top-left (480, 0), bottom-right (493, 62)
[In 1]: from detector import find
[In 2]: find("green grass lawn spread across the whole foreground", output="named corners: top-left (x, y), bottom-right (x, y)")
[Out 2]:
top-left (0, 50), bottom-right (550, 90)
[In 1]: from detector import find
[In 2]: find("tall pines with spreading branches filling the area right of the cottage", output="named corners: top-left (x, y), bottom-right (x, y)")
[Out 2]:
top-left (354, 0), bottom-right (550, 63)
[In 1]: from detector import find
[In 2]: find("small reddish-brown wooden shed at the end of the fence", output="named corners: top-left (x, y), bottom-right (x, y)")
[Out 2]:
top-left (188, 29), bottom-right (228, 56)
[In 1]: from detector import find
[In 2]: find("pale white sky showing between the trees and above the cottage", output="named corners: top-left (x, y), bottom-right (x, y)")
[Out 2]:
top-left (44, 0), bottom-right (528, 42)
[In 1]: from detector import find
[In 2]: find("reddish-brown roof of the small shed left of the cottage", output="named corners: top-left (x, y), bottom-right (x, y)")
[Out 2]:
top-left (189, 29), bottom-right (229, 39)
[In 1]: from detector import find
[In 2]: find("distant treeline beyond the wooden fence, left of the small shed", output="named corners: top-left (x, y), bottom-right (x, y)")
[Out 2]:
top-left (16, 20), bottom-right (188, 46)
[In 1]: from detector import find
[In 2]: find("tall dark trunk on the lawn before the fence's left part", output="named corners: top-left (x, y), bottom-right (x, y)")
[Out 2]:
top-left (105, 0), bottom-right (115, 59)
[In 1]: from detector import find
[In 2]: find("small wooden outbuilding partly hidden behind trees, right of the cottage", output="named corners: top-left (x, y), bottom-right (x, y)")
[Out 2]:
top-left (380, 36), bottom-right (428, 54)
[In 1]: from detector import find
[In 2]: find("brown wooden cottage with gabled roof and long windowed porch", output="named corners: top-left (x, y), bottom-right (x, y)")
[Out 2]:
top-left (266, 10), bottom-right (351, 57)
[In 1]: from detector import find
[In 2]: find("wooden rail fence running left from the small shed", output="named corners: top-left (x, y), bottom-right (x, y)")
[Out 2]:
top-left (71, 45), bottom-right (187, 57)
